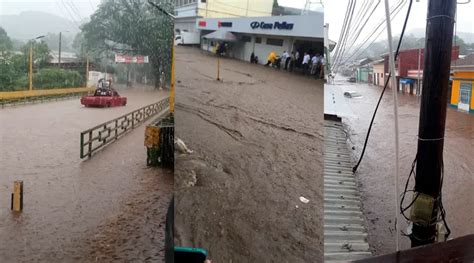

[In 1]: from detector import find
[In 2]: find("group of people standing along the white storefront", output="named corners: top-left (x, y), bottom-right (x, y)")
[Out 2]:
top-left (260, 50), bottom-right (326, 78)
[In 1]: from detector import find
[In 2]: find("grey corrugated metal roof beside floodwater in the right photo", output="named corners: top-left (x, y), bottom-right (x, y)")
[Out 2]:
top-left (324, 120), bottom-right (372, 263)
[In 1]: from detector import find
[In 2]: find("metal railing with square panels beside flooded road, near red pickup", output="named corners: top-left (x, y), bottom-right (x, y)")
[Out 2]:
top-left (81, 98), bottom-right (169, 159)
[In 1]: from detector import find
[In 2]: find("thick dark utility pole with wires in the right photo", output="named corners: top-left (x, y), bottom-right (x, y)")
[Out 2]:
top-left (410, 0), bottom-right (456, 247)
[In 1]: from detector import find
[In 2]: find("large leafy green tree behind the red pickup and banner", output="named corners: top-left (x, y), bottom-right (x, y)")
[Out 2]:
top-left (82, 0), bottom-right (174, 89)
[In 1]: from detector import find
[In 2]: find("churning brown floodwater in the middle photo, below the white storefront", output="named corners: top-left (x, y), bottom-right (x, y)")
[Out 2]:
top-left (175, 47), bottom-right (323, 262)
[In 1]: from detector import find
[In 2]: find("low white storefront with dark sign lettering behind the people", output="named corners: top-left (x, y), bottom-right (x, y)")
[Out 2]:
top-left (196, 13), bottom-right (324, 64)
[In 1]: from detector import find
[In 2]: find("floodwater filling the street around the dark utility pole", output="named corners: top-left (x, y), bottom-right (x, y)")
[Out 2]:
top-left (336, 78), bottom-right (474, 255)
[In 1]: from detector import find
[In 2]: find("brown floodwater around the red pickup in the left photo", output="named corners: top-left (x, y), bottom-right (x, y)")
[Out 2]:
top-left (0, 87), bottom-right (173, 262)
